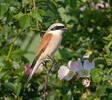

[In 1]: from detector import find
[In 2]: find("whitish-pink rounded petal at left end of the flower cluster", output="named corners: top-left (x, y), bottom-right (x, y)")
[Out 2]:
top-left (58, 65), bottom-right (69, 80)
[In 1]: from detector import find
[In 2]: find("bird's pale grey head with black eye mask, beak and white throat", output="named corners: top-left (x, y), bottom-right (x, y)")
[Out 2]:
top-left (46, 23), bottom-right (67, 34)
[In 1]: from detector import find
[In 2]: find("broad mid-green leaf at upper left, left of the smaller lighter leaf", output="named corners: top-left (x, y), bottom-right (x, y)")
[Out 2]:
top-left (19, 15), bottom-right (30, 30)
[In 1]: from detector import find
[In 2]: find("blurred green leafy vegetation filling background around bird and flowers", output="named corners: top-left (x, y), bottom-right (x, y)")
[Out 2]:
top-left (0, 0), bottom-right (112, 100)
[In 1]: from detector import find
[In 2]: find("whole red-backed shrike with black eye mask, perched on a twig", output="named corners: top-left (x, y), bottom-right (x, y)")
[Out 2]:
top-left (27, 23), bottom-right (66, 83)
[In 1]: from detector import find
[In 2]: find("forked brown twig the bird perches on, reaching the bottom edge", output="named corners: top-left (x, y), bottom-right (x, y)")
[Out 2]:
top-left (44, 60), bottom-right (56, 100)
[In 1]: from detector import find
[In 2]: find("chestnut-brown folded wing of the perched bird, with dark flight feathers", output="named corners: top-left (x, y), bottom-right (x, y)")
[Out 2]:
top-left (31, 33), bottom-right (52, 68)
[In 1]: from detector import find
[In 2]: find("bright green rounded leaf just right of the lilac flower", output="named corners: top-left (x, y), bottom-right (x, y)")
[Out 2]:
top-left (91, 68), bottom-right (103, 83)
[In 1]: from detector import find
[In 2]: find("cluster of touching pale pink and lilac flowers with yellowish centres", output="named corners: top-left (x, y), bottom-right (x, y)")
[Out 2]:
top-left (58, 59), bottom-right (95, 81)
